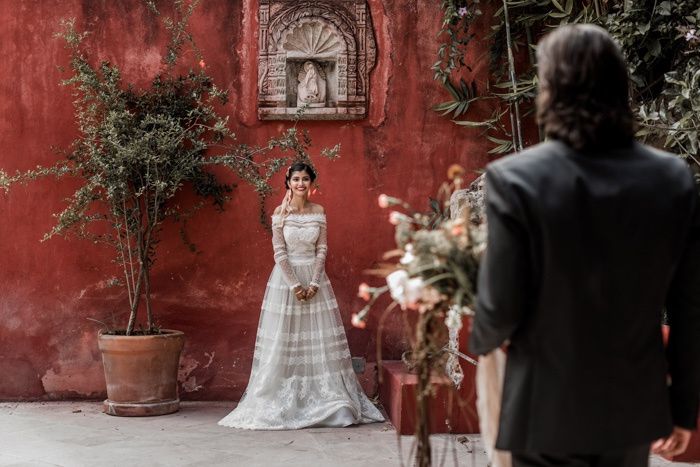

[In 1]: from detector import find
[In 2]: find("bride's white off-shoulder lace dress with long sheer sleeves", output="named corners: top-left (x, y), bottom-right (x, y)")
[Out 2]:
top-left (219, 214), bottom-right (384, 430)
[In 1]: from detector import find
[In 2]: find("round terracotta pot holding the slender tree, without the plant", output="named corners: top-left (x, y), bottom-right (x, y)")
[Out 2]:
top-left (98, 329), bottom-right (185, 417)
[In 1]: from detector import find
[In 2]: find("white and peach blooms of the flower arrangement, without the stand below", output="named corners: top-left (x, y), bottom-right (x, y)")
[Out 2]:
top-left (352, 165), bottom-right (486, 328)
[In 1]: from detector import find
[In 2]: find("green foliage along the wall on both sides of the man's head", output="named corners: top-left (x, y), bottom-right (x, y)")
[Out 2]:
top-left (434, 0), bottom-right (700, 164)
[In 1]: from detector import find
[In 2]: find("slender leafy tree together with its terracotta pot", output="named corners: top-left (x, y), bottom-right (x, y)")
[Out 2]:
top-left (0, 1), bottom-right (337, 416)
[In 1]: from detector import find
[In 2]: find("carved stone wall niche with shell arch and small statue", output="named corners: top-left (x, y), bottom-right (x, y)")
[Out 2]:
top-left (258, 0), bottom-right (377, 120)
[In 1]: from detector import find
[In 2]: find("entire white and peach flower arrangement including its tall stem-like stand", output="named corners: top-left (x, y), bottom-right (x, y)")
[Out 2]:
top-left (352, 165), bottom-right (486, 466)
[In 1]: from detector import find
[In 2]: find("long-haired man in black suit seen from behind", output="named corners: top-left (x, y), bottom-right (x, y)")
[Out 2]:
top-left (470, 25), bottom-right (700, 467)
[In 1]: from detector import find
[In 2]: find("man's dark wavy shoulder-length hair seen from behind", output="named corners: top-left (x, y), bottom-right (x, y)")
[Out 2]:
top-left (537, 24), bottom-right (634, 151)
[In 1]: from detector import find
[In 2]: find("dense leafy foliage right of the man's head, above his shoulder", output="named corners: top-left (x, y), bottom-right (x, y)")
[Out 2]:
top-left (604, 1), bottom-right (700, 166)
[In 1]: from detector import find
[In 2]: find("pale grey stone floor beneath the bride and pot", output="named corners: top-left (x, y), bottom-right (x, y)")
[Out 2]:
top-left (0, 402), bottom-right (691, 467)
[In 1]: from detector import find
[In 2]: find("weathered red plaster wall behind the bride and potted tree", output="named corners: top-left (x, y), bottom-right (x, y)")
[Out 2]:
top-left (0, 0), bottom-right (489, 399)
